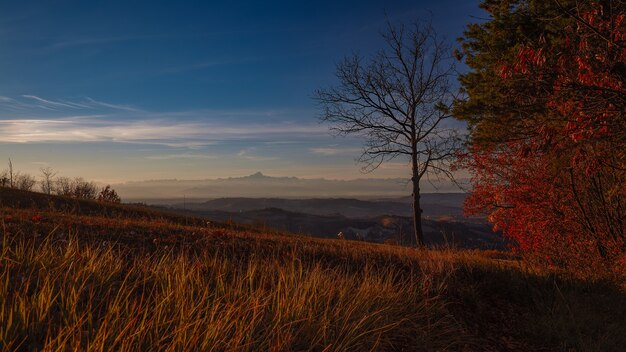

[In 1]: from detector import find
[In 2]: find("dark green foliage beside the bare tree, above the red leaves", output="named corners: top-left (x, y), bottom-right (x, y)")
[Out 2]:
top-left (454, 0), bottom-right (572, 143)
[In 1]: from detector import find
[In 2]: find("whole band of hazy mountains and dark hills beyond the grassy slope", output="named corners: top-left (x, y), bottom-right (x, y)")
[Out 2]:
top-left (114, 172), bottom-right (492, 248)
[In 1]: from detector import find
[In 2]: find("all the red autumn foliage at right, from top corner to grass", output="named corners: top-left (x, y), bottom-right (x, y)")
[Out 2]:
top-left (463, 2), bottom-right (626, 274)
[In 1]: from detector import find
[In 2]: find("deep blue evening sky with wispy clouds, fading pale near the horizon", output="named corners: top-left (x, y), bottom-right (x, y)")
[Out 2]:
top-left (0, 0), bottom-right (481, 183)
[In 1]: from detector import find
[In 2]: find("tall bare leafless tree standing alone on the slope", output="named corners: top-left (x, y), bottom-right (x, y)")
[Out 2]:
top-left (314, 23), bottom-right (461, 246)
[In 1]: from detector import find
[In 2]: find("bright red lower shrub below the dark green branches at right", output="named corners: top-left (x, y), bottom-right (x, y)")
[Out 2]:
top-left (466, 145), bottom-right (626, 277)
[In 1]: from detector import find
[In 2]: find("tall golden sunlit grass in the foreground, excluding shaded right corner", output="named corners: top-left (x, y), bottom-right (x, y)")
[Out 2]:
top-left (0, 227), bottom-right (467, 351)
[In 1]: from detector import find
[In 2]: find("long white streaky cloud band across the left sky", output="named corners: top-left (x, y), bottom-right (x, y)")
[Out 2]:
top-left (0, 94), bottom-right (328, 153)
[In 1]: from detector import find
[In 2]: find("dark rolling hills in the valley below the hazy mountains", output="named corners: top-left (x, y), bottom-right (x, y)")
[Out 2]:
top-left (158, 193), bottom-right (504, 249)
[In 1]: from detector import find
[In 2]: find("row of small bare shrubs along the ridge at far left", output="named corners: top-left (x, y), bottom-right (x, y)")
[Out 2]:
top-left (0, 159), bottom-right (121, 203)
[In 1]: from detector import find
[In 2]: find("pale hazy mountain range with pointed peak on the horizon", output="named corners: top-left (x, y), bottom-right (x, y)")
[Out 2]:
top-left (113, 172), bottom-right (459, 202)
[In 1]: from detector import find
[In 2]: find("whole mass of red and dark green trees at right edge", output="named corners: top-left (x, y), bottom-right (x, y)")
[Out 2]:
top-left (455, 0), bottom-right (626, 274)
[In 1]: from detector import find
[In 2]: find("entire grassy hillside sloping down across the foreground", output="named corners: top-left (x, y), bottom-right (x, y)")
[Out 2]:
top-left (0, 189), bottom-right (626, 351)
